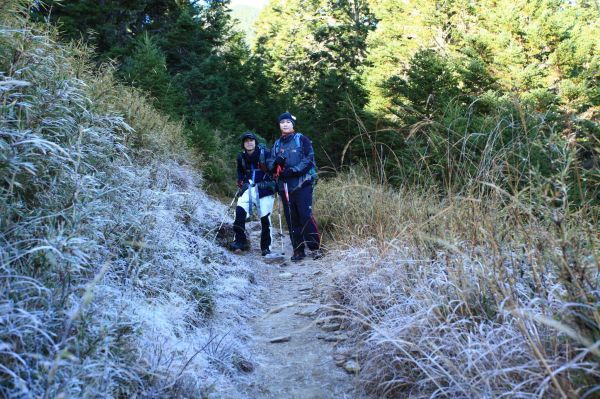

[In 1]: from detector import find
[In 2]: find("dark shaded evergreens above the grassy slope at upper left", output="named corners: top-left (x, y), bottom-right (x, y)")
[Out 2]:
top-left (34, 0), bottom-right (274, 193)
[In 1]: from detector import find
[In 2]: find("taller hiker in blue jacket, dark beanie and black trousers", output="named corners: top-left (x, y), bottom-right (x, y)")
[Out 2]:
top-left (267, 112), bottom-right (323, 262)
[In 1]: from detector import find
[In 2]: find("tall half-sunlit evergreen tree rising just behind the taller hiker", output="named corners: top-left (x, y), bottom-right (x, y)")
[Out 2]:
top-left (255, 0), bottom-right (376, 168)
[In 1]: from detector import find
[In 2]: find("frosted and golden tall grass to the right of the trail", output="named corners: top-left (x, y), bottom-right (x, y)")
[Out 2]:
top-left (315, 164), bottom-right (600, 398)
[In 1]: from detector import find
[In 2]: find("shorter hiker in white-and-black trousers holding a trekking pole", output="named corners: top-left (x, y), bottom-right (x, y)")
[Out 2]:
top-left (229, 132), bottom-right (275, 256)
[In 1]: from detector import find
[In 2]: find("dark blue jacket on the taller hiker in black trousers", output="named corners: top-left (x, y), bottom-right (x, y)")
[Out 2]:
top-left (267, 133), bottom-right (315, 191)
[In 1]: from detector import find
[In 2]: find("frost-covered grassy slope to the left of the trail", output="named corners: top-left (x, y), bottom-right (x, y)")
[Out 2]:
top-left (0, 0), bottom-right (253, 398)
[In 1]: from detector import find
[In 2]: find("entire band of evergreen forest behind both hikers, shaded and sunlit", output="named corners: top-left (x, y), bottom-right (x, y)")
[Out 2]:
top-left (34, 0), bottom-right (600, 204)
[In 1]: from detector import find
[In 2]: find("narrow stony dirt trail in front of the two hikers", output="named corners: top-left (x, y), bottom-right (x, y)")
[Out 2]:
top-left (233, 226), bottom-right (356, 399)
